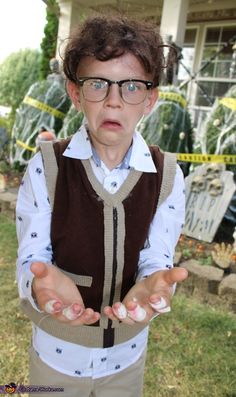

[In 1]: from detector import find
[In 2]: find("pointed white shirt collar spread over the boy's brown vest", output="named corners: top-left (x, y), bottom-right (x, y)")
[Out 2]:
top-left (63, 125), bottom-right (157, 172)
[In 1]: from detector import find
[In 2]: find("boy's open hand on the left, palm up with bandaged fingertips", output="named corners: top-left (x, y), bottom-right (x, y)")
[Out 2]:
top-left (30, 262), bottom-right (100, 325)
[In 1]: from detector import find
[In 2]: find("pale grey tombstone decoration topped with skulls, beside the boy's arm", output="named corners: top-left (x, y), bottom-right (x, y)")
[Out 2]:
top-left (183, 163), bottom-right (236, 242)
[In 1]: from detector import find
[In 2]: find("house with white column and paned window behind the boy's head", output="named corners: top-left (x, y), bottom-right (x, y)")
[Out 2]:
top-left (53, 0), bottom-right (236, 128)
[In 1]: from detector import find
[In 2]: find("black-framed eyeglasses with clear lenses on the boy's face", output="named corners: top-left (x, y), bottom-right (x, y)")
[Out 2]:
top-left (77, 77), bottom-right (153, 105)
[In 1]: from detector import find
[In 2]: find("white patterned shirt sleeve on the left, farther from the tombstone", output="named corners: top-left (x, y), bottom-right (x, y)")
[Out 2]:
top-left (16, 152), bottom-right (52, 310)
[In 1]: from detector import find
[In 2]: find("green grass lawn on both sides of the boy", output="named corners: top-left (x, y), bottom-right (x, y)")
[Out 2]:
top-left (0, 215), bottom-right (236, 397)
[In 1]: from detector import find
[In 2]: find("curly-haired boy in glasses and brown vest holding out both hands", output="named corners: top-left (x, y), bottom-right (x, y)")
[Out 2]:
top-left (17, 17), bottom-right (187, 397)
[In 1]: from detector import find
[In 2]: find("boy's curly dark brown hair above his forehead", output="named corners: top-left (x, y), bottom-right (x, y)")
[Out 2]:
top-left (63, 16), bottom-right (171, 86)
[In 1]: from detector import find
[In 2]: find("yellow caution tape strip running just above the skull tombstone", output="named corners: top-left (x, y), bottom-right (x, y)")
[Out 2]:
top-left (176, 153), bottom-right (236, 164)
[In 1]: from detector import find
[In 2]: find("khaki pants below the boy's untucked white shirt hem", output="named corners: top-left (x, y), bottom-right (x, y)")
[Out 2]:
top-left (29, 348), bottom-right (146, 397)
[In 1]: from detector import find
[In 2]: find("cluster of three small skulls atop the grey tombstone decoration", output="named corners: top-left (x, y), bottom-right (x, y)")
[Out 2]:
top-left (190, 163), bottom-right (224, 197)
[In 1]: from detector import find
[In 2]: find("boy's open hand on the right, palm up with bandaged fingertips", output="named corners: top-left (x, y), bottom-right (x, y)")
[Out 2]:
top-left (104, 267), bottom-right (188, 325)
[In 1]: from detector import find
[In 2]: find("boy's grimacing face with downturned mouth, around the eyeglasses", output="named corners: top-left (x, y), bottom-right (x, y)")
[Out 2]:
top-left (68, 53), bottom-right (157, 150)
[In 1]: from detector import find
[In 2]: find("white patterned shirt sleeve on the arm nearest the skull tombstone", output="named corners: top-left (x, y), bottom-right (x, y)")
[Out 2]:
top-left (137, 165), bottom-right (185, 281)
